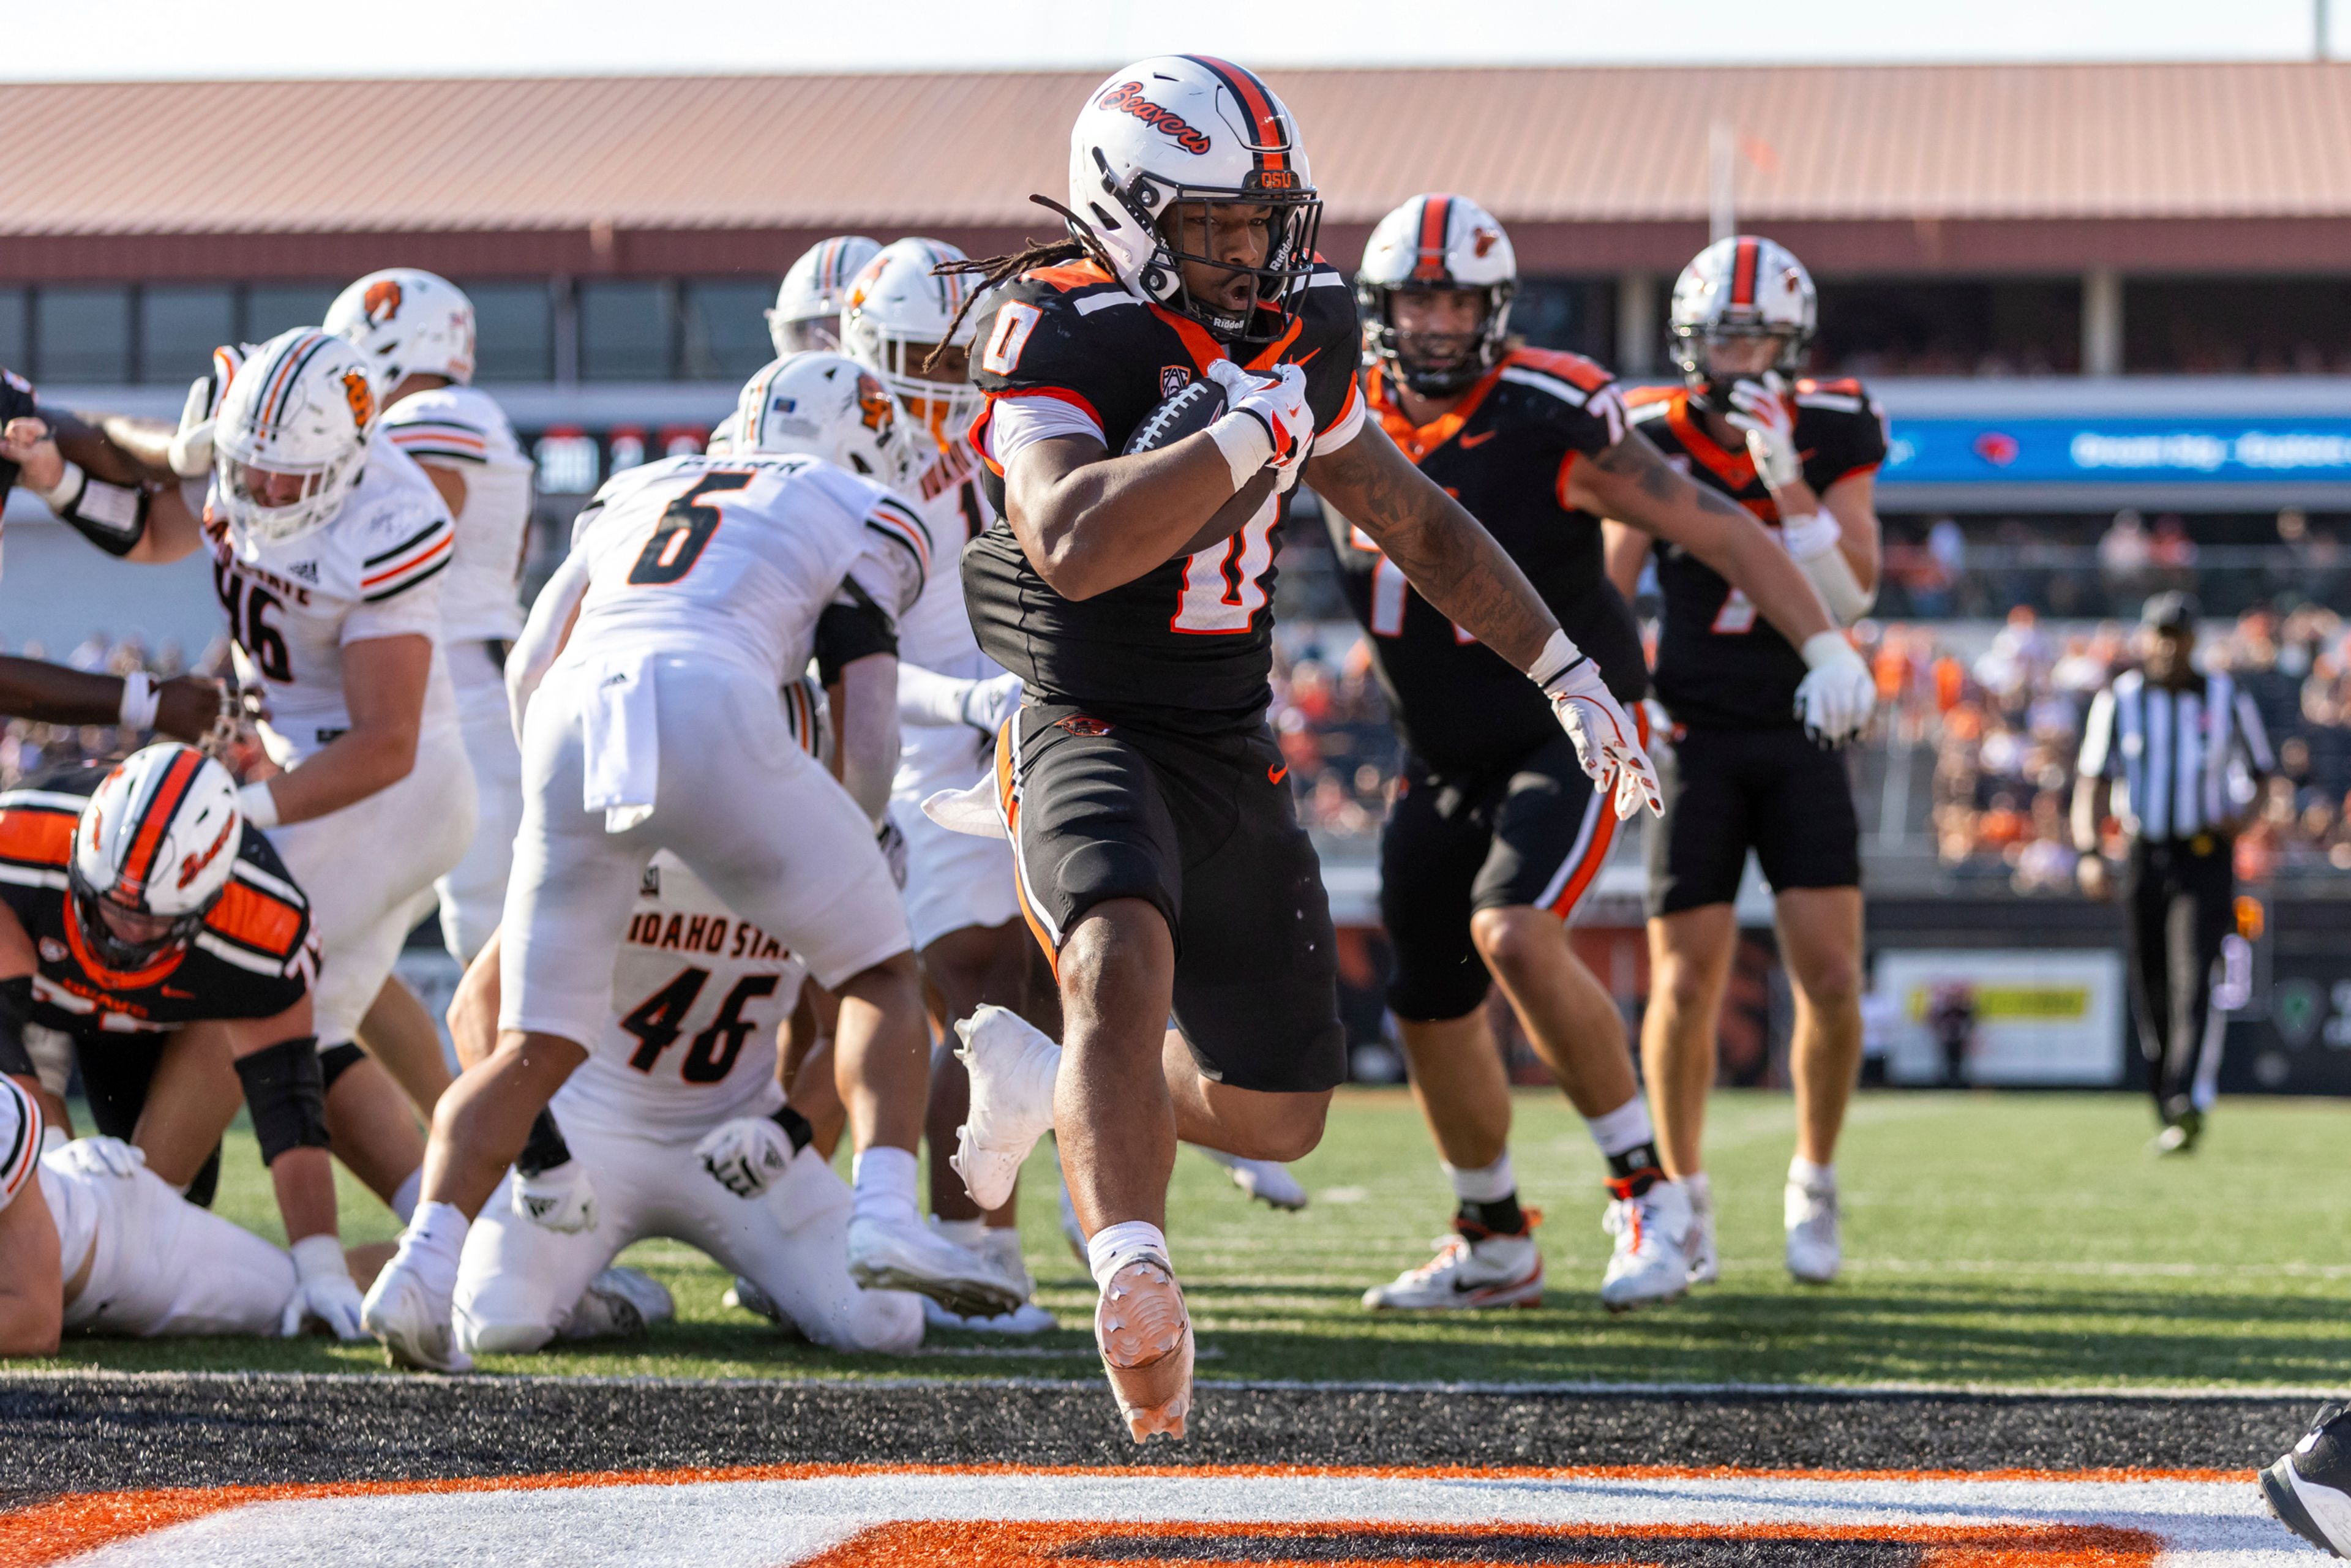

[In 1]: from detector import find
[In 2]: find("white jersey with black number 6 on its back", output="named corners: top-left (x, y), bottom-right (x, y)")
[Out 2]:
top-left (560, 454), bottom-right (931, 686)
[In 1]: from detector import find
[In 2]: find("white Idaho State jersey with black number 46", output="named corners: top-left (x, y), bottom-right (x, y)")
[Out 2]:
top-left (555, 851), bottom-right (809, 1138)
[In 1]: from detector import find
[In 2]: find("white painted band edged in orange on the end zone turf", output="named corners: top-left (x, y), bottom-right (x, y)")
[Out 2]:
top-left (55, 1474), bottom-right (2311, 1568)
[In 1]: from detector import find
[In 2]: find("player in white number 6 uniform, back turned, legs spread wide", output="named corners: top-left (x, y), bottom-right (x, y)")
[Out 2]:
top-left (367, 355), bottom-right (1021, 1370)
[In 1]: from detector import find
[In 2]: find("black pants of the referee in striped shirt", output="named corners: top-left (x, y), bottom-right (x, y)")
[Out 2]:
top-left (2123, 835), bottom-right (2236, 1121)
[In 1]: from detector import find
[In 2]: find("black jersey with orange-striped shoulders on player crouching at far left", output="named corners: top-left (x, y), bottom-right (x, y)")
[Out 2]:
top-left (0, 764), bottom-right (317, 1034)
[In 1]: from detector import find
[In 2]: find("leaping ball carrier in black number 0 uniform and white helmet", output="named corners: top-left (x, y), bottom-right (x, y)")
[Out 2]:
top-left (936, 56), bottom-right (1692, 1439)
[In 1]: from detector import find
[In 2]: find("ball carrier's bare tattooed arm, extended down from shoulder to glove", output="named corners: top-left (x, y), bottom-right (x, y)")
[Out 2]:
top-left (1307, 423), bottom-right (1559, 670)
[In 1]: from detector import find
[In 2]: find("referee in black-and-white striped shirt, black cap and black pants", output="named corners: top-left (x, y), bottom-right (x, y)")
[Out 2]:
top-left (2074, 593), bottom-right (2276, 1154)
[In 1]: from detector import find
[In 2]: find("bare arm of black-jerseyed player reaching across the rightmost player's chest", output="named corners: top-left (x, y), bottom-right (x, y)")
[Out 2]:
top-left (1568, 430), bottom-right (1836, 649)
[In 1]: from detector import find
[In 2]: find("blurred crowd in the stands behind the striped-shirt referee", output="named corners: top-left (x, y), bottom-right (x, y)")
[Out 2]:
top-left (1873, 604), bottom-right (2351, 893)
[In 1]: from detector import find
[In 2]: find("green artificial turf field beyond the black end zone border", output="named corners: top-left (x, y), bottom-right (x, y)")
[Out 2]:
top-left (23, 1091), bottom-right (2351, 1387)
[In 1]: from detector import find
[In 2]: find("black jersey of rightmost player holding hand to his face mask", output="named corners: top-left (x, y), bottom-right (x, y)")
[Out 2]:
top-left (1624, 381), bottom-right (1886, 729)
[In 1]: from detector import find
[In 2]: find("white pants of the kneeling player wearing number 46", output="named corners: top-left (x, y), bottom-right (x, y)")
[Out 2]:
top-left (456, 1121), bottom-right (921, 1356)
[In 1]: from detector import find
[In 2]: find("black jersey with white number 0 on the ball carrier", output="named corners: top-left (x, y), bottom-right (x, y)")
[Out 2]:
top-left (964, 263), bottom-right (1361, 733)
